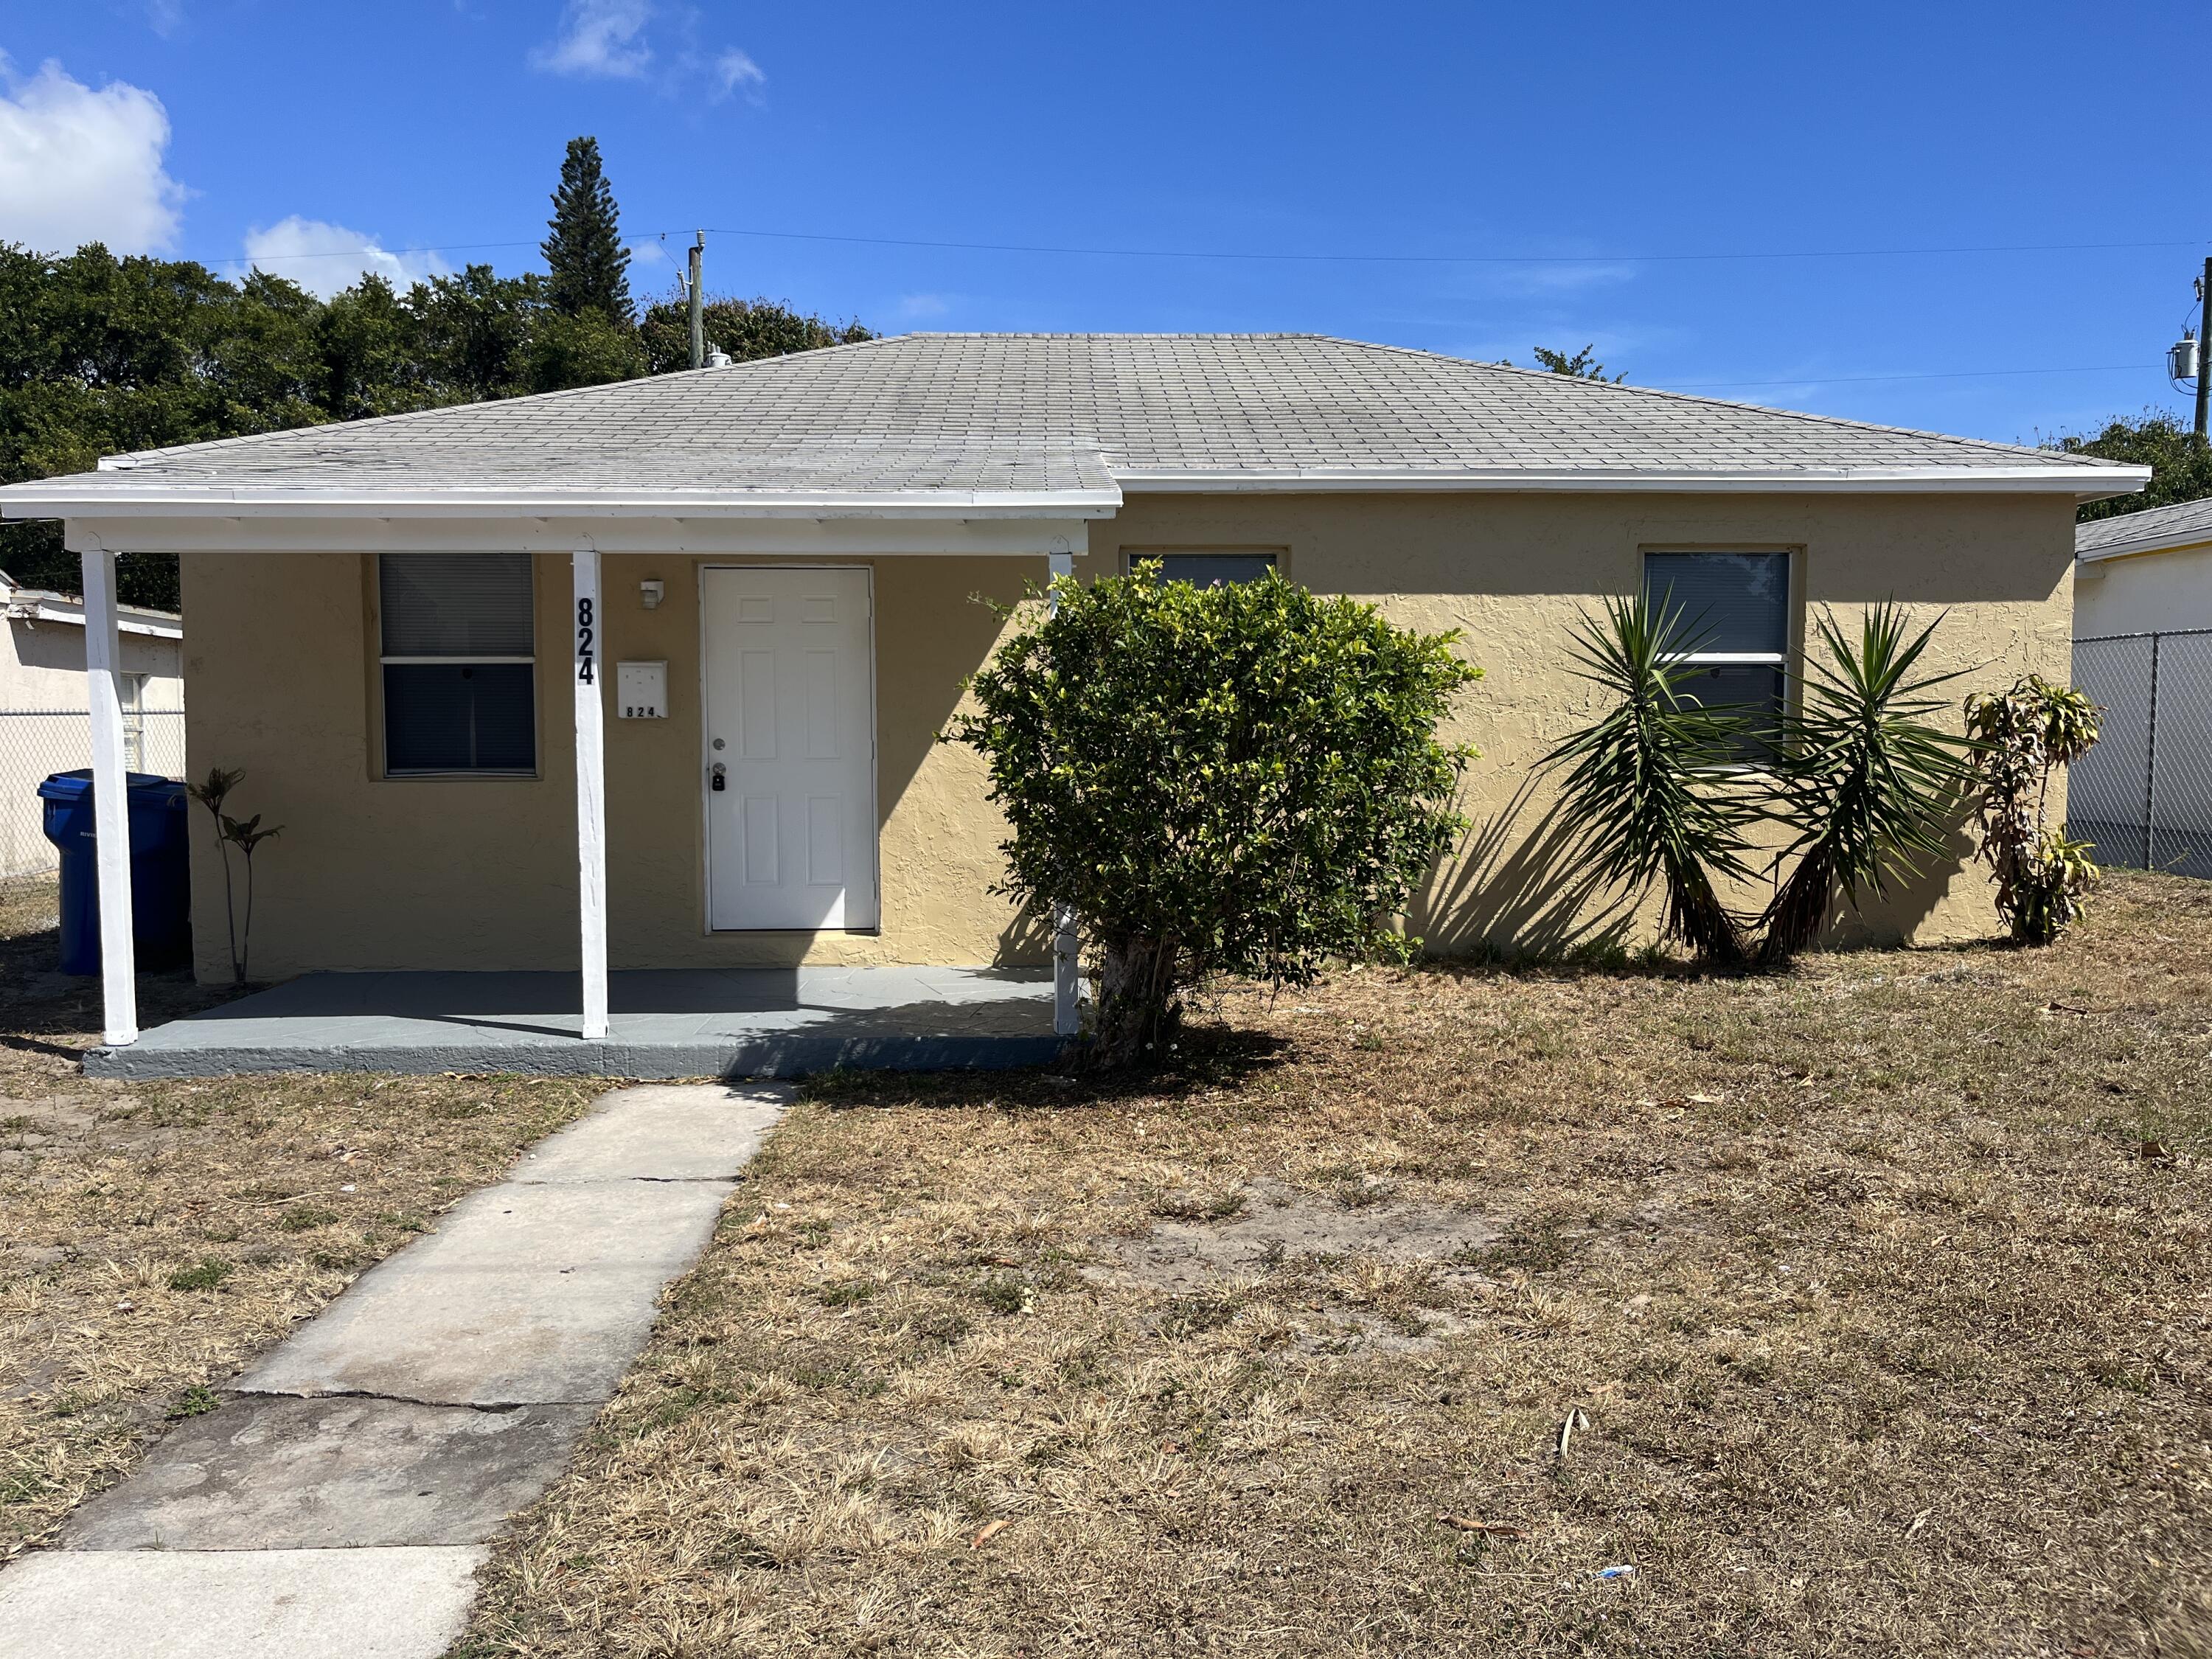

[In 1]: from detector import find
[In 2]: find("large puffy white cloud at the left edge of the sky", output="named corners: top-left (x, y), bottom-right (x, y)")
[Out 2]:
top-left (0, 53), bottom-right (184, 254)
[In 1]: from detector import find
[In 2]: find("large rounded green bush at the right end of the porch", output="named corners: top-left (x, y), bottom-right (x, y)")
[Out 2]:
top-left (945, 564), bottom-right (1480, 1066)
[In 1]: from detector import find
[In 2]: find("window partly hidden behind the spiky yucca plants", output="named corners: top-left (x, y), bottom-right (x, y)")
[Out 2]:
top-left (1644, 553), bottom-right (1790, 763)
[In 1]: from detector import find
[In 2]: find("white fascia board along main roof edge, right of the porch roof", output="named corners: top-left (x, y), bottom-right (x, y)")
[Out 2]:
top-left (1115, 467), bottom-right (2150, 500)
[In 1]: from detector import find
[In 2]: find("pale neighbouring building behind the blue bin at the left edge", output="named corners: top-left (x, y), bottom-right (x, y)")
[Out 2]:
top-left (0, 571), bottom-right (184, 876)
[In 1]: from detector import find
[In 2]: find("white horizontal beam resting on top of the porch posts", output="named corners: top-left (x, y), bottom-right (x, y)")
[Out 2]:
top-left (62, 511), bottom-right (1091, 557)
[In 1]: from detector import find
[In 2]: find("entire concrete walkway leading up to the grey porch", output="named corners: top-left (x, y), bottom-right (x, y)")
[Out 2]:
top-left (0, 1084), bottom-right (785, 1659)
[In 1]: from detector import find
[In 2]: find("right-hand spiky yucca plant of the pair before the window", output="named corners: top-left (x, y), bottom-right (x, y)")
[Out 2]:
top-left (1759, 602), bottom-right (1973, 964)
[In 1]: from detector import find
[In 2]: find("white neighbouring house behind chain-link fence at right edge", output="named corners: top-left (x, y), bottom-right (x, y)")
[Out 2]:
top-left (2066, 500), bottom-right (2212, 876)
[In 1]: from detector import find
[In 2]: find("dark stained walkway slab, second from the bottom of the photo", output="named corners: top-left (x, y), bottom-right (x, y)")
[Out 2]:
top-left (62, 1396), bottom-right (599, 1551)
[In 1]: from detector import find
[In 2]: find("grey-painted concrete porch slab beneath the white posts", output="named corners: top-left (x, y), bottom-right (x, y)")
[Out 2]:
top-left (84, 967), bottom-right (1060, 1079)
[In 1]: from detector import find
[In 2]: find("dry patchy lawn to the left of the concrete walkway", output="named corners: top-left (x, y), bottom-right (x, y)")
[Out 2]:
top-left (0, 880), bottom-right (604, 1559)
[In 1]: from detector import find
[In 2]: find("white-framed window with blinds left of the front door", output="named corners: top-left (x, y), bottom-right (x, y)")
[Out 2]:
top-left (376, 553), bottom-right (538, 776)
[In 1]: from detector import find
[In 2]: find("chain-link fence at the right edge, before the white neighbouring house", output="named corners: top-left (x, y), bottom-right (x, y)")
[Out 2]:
top-left (2066, 628), bottom-right (2212, 876)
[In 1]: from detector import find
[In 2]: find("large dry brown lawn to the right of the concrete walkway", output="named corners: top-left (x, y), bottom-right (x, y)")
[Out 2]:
top-left (462, 876), bottom-right (2212, 1657)
